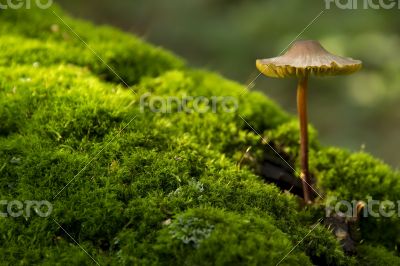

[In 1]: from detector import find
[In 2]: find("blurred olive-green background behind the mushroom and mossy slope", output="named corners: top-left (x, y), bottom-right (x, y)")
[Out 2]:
top-left (56, 0), bottom-right (400, 169)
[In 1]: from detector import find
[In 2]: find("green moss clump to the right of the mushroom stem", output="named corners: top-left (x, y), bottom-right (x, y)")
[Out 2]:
top-left (311, 148), bottom-right (400, 247)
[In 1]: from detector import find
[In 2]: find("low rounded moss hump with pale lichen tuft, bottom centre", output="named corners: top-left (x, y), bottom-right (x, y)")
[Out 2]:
top-left (155, 208), bottom-right (312, 265)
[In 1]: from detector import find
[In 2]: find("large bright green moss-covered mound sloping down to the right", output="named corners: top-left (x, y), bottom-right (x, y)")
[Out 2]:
top-left (0, 4), bottom-right (400, 265)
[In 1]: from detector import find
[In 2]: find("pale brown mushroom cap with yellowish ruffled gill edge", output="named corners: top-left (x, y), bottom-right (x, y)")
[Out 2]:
top-left (256, 41), bottom-right (362, 78)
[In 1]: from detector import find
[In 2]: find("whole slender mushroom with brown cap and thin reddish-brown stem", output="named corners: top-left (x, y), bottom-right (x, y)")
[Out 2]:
top-left (256, 40), bottom-right (362, 203)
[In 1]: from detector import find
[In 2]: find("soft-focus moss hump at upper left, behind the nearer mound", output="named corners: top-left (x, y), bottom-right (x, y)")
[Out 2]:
top-left (0, 7), bottom-right (184, 86)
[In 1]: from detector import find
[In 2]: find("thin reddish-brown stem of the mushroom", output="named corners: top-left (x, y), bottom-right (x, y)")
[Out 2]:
top-left (297, 74), bottom-right (311, 204)
